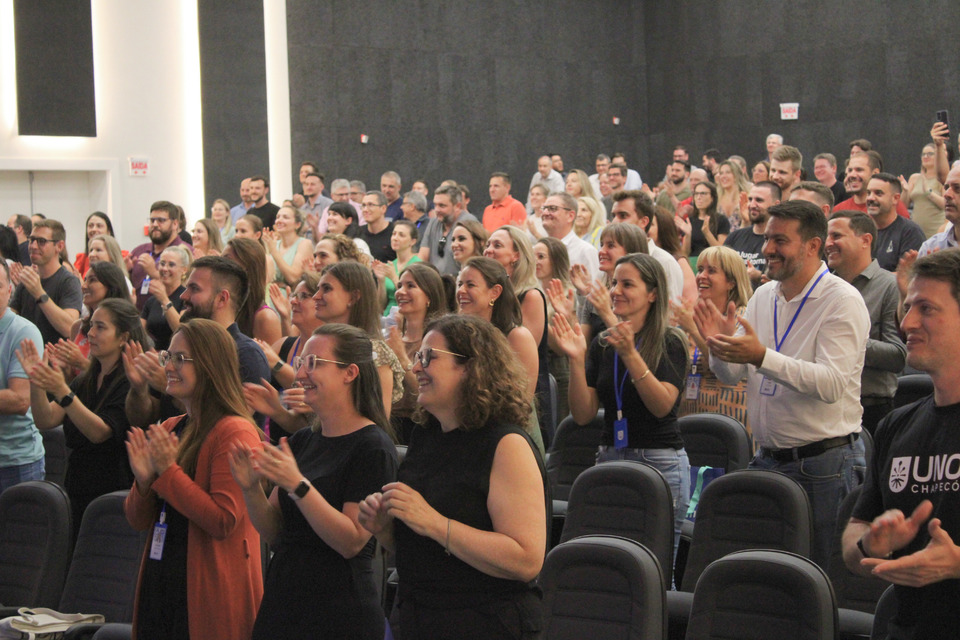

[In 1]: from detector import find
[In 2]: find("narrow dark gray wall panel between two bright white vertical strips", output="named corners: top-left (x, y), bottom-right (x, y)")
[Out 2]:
top-left (197, 0), bottom-right (268, 210)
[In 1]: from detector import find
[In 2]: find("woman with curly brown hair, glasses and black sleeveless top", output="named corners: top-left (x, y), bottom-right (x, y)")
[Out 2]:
top-left (360, 315), bottom-right (547, 640)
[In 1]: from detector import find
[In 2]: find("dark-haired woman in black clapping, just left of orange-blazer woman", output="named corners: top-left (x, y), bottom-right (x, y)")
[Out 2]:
top-left (17, 298), bottom-right (151, 536)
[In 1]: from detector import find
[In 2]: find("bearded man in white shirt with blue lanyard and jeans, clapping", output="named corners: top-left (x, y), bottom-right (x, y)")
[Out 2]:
top-left (694, 200), bottom-right (870, 566)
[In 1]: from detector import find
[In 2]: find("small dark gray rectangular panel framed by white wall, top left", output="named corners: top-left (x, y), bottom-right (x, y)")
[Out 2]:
top-left (13, 0), bottom-right (97, 137)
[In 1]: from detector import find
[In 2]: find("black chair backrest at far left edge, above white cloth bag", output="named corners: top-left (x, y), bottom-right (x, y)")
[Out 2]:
top-left (0, 480), bottom-right (73, 609)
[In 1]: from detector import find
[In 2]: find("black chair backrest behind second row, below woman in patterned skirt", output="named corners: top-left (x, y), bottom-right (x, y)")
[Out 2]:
top-left (677, 413), bottom-right (753, 472)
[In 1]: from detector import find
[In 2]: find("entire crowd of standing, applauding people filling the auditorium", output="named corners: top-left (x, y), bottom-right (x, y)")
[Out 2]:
top-left (0, 124), bottom-right (960, 638)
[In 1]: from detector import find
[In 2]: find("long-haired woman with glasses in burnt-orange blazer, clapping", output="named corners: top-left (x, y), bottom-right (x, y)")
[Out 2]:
top-left (124, 319), bottom-right (263, 640)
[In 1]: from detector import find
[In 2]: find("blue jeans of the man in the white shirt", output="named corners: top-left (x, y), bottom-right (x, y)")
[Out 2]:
top-left (750, 439), bottom-right (867, 569)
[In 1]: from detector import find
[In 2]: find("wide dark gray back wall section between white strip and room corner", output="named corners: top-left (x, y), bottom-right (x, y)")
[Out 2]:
top-left (287, 0), bottom-right (647, 212)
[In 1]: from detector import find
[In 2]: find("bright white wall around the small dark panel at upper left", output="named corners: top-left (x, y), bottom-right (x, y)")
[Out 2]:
top-left (0, 0), bottom-right (205, 253)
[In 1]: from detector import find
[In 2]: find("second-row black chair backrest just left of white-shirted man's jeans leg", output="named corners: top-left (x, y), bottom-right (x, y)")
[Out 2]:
top-left (681, 469), bottom-right (813, 591)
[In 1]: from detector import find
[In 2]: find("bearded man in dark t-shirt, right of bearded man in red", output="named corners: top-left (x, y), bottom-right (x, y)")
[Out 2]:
top-left (867, 173), bottom-right (927, 271)
